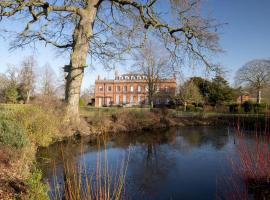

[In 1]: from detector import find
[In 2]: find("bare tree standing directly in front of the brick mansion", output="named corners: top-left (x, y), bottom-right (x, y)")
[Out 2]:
top-left (132, 40), bottom-right (174, 108)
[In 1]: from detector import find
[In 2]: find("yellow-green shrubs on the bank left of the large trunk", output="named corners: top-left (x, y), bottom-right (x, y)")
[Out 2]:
top-left (0, 104), bottom-right (63, 146)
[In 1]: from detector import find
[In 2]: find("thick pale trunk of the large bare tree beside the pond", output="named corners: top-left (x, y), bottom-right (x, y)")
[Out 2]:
top-left (65, 0), bottom-right (97, 123)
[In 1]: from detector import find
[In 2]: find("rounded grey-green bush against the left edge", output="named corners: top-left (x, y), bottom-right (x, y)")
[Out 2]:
top-left (0, 119), bottom-right (29, 149)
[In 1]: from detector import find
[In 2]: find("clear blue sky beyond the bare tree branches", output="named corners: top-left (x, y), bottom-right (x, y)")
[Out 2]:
top-left (0, 0), bottom-right (270, 89)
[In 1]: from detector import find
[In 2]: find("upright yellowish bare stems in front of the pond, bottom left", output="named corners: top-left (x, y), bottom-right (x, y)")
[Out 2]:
top-left (51, 138), bottom-right (129, 200)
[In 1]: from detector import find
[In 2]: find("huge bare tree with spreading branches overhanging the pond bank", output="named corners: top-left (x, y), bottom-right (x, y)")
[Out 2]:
top-left (0, 0), bottom-right (219, 121)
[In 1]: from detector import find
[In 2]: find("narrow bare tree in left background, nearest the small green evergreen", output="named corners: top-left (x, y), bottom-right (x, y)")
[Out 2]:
top-left (19, 56), bottom-right (37, 103)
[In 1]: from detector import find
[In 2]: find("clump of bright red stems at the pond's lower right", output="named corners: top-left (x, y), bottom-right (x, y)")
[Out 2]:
top-left (223, 116), bottom-right (270, 200)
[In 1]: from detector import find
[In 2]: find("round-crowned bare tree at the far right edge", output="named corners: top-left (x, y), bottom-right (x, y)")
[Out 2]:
top-left (235, 60), bottom-right (270, 103)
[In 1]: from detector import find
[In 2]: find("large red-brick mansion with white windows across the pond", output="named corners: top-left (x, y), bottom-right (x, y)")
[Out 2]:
top-left (95, 73), bottom-right (176, 107)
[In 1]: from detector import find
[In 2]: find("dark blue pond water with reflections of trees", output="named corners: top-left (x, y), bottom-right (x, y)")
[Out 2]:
top-left (37, 127), bottom-right (260, 200)
